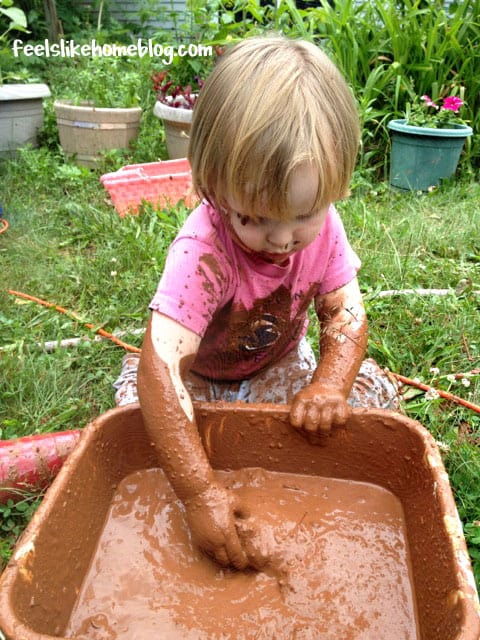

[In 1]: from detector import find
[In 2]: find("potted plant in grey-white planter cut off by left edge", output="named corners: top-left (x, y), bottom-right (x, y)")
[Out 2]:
top-left (0, 0), bottom-right (50, 157)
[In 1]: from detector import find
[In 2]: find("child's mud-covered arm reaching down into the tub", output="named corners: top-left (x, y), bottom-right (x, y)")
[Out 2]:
top-left (138, 311), bottom-right (249, 569)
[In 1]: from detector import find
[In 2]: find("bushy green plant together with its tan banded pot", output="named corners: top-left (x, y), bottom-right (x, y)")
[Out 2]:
top-left (54, 57), bottom-right (142, 167)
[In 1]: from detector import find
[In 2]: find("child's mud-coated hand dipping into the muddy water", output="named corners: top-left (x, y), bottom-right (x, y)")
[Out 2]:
top-left (184, 484), bottom-right (250, 569)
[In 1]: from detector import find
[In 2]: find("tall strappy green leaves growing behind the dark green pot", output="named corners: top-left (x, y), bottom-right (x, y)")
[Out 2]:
top-left (303, 0), bottom-right (480, 175)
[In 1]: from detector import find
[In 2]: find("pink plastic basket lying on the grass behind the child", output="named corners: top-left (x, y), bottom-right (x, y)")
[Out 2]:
top-left (100, 158), bottom-right (198, 217)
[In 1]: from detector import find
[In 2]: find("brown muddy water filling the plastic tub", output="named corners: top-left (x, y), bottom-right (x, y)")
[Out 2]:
top-left (66, 469), bottom-right (418, 640)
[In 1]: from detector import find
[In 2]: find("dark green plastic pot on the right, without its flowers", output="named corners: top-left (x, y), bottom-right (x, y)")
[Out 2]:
top-left (388, 120), bottom-right (473, 191)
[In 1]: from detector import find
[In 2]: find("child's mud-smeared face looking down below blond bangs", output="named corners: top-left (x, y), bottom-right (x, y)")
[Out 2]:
top-left (227, 166), bottom-right (328, 262)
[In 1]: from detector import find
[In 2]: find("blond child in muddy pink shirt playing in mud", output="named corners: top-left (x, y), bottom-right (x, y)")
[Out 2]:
top-left (117, 36), bottom-right (395, 568)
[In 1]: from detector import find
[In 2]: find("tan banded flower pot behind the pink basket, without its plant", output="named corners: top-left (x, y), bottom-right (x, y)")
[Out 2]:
top-left (54, 100), bottom-right (142, 167)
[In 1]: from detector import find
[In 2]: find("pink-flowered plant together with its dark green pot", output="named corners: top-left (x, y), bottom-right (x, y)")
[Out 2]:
top-left (388, 95), bottom-right (472, 191)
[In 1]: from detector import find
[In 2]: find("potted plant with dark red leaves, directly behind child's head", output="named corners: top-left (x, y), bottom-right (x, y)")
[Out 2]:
top-left (152, 51), bottom-right (215, 159)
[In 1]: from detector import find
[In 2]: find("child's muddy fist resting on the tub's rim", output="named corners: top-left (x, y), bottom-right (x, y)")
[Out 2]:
top-left (290, 382), bottom-right (351, 433)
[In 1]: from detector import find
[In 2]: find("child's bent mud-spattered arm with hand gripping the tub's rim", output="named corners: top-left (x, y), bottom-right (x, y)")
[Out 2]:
top-left (290, 278), bottom-right (367, 432)
